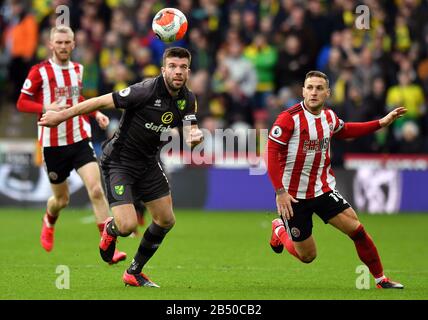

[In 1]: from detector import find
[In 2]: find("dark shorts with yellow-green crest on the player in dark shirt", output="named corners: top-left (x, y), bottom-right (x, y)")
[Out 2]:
top-left (101, 161), bottom-right (170, 207)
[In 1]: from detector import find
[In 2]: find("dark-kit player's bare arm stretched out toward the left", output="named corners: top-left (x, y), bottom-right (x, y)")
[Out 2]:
top-left (37, 93), bottom-right (114, 127)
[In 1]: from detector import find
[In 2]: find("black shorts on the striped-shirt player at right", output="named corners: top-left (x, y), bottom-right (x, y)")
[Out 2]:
top-left (284, 190), bottom-right (351, 242)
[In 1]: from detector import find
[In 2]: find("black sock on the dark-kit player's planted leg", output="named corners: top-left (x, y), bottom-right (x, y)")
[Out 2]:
top-left (127, 222), bottom-right (171, 274)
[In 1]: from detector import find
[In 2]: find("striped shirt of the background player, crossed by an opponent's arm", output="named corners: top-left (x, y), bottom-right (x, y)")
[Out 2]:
top-left (21, 59), bottom-right (91, 147)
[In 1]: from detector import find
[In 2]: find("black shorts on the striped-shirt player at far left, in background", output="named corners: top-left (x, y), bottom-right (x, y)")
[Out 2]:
top-left (43, 139), bottom-right (97, 184)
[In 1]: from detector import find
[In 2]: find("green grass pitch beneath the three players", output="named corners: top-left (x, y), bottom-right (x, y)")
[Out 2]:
top-left (0, 209), bottom-right (428, 300)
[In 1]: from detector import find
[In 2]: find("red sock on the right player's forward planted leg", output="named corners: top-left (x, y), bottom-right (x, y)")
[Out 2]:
top-left (349, 225), bottom-right (383, 278)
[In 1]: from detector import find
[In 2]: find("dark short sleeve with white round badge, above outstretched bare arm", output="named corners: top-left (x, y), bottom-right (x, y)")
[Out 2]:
top-left (113, 81), bottom-right (152, 109)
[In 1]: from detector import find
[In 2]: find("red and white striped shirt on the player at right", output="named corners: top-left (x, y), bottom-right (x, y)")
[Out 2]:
top-left (268, 102), bottom-right (344, 199)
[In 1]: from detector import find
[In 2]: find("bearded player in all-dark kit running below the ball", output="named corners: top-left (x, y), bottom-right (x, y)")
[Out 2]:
top-left (39, 47), bottom-right (203, 287)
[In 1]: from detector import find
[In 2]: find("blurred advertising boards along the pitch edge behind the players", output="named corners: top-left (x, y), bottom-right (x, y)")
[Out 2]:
top-left (0, 139), bottom-right (428, 214)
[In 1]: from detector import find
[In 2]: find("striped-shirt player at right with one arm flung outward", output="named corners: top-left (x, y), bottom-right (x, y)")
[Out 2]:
top-left (267, 71), bottom-right (406, 289)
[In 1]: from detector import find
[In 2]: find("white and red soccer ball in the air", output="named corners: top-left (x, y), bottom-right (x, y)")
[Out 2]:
top-left (152, 8), bottom-right (187, 43)
